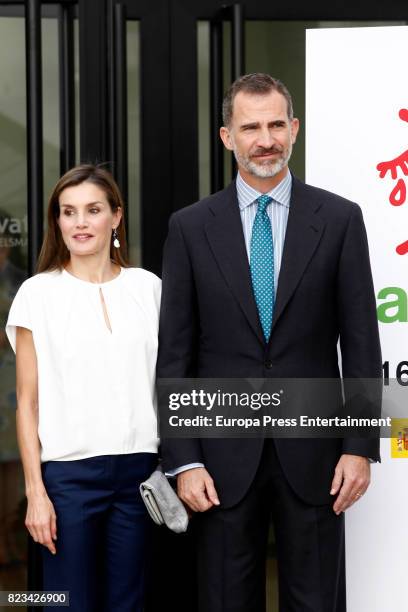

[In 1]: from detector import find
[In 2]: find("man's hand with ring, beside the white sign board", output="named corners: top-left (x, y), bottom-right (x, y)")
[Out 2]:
top-left (330, 455), bottom-right (370, 515)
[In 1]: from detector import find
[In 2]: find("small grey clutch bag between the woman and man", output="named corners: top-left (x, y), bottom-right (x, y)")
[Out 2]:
top-left (140, 467), bottom-right (188, 533)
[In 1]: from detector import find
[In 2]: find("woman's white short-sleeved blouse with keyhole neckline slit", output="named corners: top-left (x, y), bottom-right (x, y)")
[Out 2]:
top-left (6, 268), bottom-right (161, 461)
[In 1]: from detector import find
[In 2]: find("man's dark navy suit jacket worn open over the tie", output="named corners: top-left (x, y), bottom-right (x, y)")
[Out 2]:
top-left (157, 178), bottom-right (382, 507)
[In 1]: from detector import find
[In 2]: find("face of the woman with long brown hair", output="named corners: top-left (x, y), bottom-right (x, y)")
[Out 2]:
top-left (58, 181), bottom-right (122, 258)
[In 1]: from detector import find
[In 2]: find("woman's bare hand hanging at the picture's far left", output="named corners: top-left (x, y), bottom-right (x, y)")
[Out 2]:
top-left (25, 489), bottom-right (57, 555)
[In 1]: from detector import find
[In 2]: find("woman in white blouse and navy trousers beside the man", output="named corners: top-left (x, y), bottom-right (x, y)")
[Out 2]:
top-left (6, 165), bottom-right (160, 612)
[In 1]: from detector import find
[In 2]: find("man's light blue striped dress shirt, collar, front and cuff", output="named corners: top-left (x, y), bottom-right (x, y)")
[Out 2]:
top-left (166, 172), bottom-right (292, 476)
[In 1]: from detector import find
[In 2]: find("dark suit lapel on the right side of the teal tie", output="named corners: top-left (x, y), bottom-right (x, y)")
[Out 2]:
top-left (271, 177), bottom-right (324, 336)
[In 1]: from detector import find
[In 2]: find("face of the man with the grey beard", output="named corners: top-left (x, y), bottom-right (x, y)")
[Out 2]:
top-left (220, 91), bottom-right (299, 178)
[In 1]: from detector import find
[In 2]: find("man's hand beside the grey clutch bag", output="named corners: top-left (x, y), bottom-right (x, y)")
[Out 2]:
top-left (177, 468), bottom-right (220, 512)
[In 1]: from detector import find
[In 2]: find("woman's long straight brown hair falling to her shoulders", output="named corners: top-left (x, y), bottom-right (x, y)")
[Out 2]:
top-left (37, 164), bottom-right (130, 272)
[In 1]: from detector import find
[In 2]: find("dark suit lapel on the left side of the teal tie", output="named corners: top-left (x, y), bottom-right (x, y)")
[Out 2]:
top-left (205, 181), bottom-right (265, 344)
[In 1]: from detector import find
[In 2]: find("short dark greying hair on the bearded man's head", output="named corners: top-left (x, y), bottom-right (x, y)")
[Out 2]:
top-left (222, 72), bottom-right (293, 127)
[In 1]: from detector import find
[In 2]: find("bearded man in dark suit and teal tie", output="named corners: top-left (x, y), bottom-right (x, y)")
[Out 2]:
top-left (158, 74), bottom-right (381, 612)
